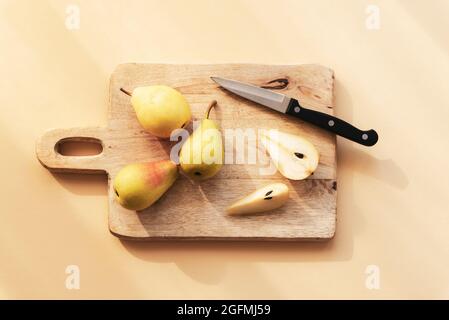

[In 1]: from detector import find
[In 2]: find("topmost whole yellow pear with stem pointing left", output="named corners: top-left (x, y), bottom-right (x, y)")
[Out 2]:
top-left (120, 85), bottom-right (191, 138)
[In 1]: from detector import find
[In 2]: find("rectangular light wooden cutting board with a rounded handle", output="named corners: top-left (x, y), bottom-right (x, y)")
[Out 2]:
top-left (36, 64), bottom-right (337, 241)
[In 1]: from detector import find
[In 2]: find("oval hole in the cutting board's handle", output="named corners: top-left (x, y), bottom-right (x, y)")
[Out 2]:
top-left (55, 137), bottom-right (103, 157)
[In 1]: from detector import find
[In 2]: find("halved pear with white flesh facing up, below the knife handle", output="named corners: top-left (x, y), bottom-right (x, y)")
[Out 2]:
top-left (261, 130), bottom-right (320, 180)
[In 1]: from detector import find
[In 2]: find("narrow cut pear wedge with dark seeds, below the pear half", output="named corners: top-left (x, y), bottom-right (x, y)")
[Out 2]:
top-left (226, 183), bottom-right (288, 215)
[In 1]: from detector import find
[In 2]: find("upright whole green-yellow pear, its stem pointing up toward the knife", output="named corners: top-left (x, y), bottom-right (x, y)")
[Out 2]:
top-left (179, 100), bottom-right (224, 181)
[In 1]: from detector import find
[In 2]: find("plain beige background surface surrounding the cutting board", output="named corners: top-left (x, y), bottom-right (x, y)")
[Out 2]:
top-left (0, 0), bottom-right (449, 299)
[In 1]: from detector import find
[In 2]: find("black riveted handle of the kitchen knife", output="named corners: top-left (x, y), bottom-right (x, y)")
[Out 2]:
top-left (286, 99), bottom-right (379, 147)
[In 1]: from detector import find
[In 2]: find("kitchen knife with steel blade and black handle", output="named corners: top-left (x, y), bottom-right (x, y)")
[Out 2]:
top-left (211, 77), bottom-right (378, 146)
